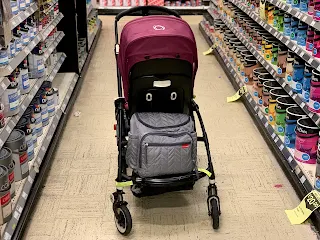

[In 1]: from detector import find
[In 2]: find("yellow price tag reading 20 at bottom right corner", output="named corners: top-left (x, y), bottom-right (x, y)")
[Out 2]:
top-left (285, 190), bottom-right (320, 224)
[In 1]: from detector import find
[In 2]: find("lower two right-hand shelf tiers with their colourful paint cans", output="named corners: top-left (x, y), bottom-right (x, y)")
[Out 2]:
top-left (200, 3), bottom-right (320, 228)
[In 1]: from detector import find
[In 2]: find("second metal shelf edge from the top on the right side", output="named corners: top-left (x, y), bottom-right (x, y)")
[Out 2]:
top-left (228, 0), bottom-right (320, 71)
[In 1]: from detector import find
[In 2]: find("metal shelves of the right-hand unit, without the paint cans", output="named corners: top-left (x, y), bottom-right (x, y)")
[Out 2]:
top-left (199, 0), bottom-right (320, 229)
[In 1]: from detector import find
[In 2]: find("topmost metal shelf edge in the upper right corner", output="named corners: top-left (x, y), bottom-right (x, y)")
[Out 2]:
top-left (267, 0), bottom-right (320, 30)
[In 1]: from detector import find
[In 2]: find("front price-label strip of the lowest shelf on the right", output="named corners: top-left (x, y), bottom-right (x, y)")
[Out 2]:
top-left (199, 20), bottom-right (320, 229)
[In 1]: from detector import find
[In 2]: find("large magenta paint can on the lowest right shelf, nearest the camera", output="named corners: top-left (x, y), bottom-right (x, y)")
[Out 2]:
top-left (294, 118), bottom-right (319, 164)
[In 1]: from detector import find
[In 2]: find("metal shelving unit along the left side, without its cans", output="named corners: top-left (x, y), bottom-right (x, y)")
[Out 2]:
top-left (0, 0), bottom-right (102, 240)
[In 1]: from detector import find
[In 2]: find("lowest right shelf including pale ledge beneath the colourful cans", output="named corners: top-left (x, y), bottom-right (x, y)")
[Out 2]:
top-left (199, 17), bottom-right (315, 191)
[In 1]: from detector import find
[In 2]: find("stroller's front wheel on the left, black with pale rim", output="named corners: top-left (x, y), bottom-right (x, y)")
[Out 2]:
top-left (114, 205), bottom-right (132, 236)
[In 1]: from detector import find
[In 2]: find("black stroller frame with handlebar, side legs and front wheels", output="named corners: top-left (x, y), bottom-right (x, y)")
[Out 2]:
top-left (110, 6), bottom-right (221, 235)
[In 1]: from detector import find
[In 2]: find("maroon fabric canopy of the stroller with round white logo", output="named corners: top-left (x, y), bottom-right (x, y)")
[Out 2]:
top-left (118, 16), bottom-right (198, 100)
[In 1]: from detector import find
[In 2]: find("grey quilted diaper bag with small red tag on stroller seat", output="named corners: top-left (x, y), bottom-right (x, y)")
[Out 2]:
top-left (126, 112), bottom-right (197, 178)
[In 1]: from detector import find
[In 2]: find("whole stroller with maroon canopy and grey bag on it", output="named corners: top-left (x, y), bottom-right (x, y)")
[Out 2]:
top-left (111, 6), bottom-right (221, 235)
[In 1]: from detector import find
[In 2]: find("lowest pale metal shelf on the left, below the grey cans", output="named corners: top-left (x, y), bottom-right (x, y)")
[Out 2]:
top-left (1, 73), bottom-right (79, 240)
